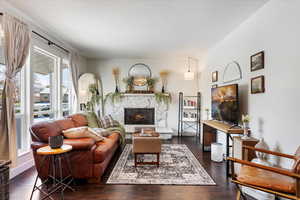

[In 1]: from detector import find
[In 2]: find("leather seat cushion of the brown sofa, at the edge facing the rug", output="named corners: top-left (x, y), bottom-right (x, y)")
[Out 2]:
top-left (94, 133), bottom-right (120, 163)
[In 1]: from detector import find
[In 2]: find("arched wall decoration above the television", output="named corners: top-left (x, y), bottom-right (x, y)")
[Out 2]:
top-left (223, 61), bottom-right (242, 83)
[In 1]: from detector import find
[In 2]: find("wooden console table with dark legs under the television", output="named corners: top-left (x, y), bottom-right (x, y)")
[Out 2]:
top-left (202, 120), bottom-right (244, 177)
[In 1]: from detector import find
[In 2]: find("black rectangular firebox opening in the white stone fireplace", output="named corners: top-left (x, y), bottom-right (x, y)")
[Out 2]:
top-left (124, 108), bottom-right (155, 125)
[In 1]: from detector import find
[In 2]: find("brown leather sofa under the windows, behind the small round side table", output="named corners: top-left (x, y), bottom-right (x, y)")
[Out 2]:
top-left (30, 114), bottom-right (120, 182)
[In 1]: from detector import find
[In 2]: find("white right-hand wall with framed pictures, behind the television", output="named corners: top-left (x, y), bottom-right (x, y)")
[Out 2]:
top-left (200, 0), bottom-right (300, 168)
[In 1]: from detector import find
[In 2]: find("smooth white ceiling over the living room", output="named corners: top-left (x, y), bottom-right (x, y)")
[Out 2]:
top-left (9, 0), bottom-right (268, 58)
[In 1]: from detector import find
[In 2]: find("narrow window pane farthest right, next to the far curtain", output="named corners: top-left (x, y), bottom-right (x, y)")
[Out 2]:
top-left (61, 59), bottom-right (72, 117)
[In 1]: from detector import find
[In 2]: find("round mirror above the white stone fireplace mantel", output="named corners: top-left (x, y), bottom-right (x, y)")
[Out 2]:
top-left (128, 63), bottom-right (152, 86)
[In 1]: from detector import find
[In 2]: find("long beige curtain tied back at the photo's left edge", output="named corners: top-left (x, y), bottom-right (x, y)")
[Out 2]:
top-left (0, 13), bottom-right (31, 166)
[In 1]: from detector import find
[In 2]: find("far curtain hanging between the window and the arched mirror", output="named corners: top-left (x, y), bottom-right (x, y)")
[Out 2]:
top-left (69, 52), bottom-right (80, 112)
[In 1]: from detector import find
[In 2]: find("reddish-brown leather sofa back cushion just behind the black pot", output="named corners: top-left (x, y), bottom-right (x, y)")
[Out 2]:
top-left (31, 121), bottom-right (62, 142)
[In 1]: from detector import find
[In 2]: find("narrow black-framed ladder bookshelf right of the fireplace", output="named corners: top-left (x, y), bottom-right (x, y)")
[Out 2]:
top-left (178, 92), bottom-right (201, 137)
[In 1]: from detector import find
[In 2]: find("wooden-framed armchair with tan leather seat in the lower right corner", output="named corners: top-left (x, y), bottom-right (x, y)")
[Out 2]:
top-left (227, 146), bottom-right (300, 200)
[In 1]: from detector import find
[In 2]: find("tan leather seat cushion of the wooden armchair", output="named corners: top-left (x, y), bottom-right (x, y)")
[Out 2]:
top-left (237, 166), bottom-right (296, 193)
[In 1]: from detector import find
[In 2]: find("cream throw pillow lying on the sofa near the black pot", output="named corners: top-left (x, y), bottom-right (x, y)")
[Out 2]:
top-left (63, 126), bottom-right (104, 142)
